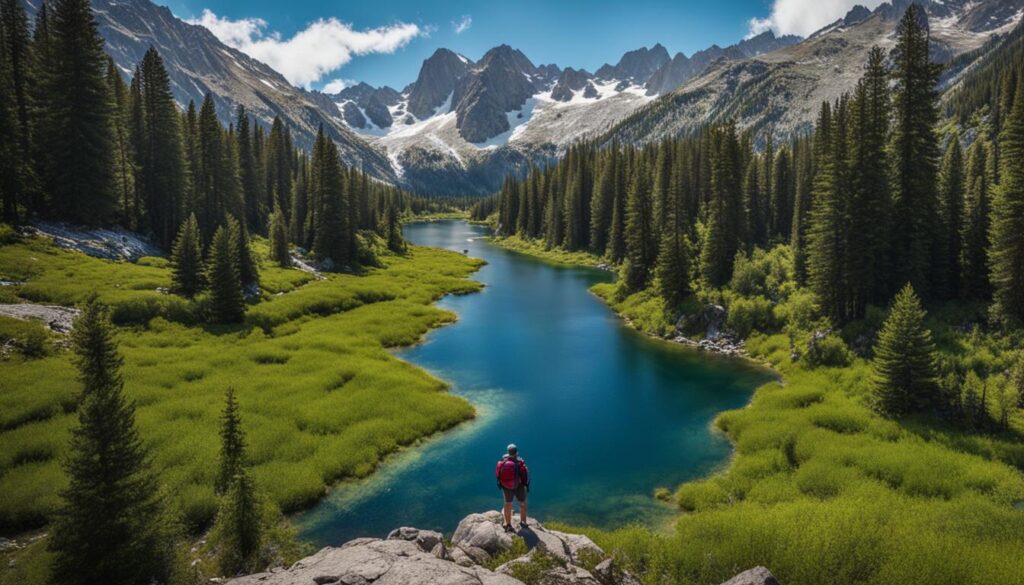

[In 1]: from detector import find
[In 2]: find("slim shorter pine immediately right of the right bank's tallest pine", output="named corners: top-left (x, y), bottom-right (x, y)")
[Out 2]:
top-left (939, 133), bottom-right (965, 298)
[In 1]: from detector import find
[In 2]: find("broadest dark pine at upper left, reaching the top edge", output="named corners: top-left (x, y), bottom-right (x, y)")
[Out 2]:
top-left (39, 0), bottom-right (118, 224)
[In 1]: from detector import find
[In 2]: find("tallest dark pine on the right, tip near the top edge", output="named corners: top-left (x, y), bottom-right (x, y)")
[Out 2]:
top-left (889, 4), bottom-right (942, 298)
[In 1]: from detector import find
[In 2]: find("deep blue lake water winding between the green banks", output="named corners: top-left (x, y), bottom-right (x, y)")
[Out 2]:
top-left (297, 221), bottom-right (770, 545)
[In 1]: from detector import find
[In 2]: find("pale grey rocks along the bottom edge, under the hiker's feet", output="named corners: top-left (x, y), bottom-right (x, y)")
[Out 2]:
top-left (228, 511), bottom-right (778, 585)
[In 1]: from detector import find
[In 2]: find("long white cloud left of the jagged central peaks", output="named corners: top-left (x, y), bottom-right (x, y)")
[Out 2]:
top-left (188, 9), bottom-right (426, 87)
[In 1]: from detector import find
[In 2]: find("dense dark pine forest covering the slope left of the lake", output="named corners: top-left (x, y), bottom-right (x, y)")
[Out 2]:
top-left (0, 0), bottom-right (460, 267)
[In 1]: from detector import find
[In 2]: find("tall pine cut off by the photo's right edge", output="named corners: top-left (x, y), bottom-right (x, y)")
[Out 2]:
top-left (988, 76), bottom-right (1024, 327)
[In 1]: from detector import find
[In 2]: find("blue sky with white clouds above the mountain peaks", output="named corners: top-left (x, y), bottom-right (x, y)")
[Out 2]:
top-left (163, 0), bottom-right (878, 89)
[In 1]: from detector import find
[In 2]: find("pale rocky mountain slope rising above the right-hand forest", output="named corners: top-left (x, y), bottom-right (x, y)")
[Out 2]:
top-left (602, 0), bottom-right (1024, 148)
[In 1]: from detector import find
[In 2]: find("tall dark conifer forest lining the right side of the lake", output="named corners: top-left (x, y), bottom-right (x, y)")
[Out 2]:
top-left (472, 5), bottom-right (1024, 327)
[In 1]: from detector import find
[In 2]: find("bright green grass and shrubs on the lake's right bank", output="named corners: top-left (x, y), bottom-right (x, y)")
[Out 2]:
top-left (487, 236), bottom-right (1024, 585)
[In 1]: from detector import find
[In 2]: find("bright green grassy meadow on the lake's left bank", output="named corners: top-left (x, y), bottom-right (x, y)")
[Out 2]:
top-left (0, 231), bottom-right (480, 533)
